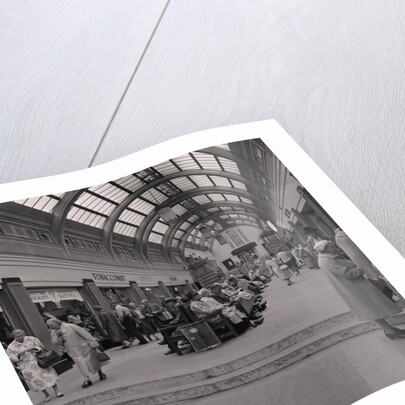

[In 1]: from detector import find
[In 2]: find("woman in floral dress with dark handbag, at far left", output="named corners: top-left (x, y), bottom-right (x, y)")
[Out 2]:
top-left (7, 329), bottom-right (63, 402)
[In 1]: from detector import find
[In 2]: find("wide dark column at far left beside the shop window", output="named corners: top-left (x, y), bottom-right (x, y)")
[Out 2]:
top-left (0, 277), bottom-right (52, 348)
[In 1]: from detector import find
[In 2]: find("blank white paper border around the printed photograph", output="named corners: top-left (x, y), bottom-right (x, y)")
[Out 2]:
top-left (0, 120), bottom-right (405, 405)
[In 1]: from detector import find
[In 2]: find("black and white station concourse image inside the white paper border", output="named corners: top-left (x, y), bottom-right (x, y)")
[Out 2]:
top-left (0, 138), bottom-right (405, 405)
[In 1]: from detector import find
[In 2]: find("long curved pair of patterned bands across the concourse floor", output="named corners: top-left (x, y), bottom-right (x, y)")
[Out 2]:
top-left (64, 312), bottom-right (405, 405)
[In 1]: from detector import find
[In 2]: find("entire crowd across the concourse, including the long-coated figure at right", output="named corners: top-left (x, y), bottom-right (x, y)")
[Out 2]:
top-left (7, 224), bottom-right (405, 401)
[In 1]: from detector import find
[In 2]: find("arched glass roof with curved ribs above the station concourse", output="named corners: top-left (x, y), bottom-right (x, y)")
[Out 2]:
top-left (11, 141), bottom-right (274, 256)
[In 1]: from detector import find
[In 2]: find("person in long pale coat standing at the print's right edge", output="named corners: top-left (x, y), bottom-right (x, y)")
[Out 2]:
top-left (314, 240), bottom-right (405, 339)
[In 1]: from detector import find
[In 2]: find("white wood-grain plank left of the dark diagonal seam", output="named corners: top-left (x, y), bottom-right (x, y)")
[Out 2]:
top-left (0, 0), bottom-right (166, 182)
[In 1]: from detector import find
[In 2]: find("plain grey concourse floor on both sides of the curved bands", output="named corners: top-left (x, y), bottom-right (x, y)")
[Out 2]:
top-left (26, 271), bottom-right (405, 405)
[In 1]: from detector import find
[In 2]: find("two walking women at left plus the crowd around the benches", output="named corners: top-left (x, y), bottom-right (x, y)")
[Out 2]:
top-left (7, 277), bottom-right (267, 402)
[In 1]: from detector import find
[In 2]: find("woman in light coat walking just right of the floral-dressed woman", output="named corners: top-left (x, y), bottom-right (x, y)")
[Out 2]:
top-left (47, 318), bottom-right (107, 388)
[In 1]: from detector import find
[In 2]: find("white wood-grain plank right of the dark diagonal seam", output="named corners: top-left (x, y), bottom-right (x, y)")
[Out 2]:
top-left (95, 0), bottom-right (405, 254)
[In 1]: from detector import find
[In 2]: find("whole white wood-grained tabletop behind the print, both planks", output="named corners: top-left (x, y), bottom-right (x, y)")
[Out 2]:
top-left (0, 0), bottom-right (405, 254)
